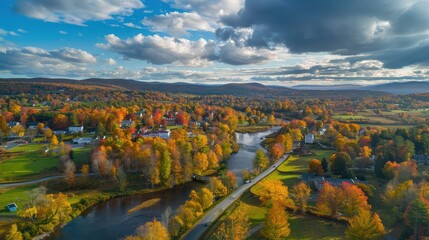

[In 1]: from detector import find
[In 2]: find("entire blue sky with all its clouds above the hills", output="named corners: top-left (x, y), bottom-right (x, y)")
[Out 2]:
top-left (0, 0), bottom-right (429, 86)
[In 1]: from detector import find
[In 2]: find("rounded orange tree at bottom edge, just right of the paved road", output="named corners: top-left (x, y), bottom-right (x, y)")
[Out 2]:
top-left (261, 203), bottom-right (290, 239)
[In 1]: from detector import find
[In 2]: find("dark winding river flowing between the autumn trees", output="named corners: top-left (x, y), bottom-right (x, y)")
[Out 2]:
top-left (48, 128), bottom-right (278, 240)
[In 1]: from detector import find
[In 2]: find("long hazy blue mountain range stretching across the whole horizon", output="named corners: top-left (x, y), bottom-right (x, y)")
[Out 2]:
top-left (0, 78), bottom-right (429, 98)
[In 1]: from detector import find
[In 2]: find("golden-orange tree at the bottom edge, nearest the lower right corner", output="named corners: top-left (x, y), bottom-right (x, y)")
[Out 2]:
top-left (345, 209), bottom-right (385, 240)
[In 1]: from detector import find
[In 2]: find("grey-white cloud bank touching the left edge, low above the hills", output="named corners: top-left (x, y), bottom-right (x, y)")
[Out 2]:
top-left (0, 47), bottom-right (97, 76)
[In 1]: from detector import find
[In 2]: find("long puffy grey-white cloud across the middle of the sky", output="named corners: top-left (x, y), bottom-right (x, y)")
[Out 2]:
top-left (97, 34), bottom-right (275, 66)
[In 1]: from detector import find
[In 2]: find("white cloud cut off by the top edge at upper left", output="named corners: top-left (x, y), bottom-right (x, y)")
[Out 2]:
top-left (15, 0), bottom-right (144, 25)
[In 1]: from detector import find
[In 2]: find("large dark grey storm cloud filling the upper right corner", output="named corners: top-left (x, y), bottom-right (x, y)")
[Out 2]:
top-left (222, 0), bottom-right (429, 68)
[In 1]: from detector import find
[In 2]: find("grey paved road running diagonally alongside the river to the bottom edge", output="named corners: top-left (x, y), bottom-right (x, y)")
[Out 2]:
top-left (182, 154), bottom-right (289, 240)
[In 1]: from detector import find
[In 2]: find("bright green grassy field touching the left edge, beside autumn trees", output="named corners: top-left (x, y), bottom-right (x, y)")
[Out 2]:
top-left (0, 144), bottom-right (58, 183)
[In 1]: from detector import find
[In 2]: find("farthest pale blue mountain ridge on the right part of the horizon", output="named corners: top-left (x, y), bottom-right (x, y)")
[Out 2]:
top-left (291, 81), bottom-right (429, 94)
